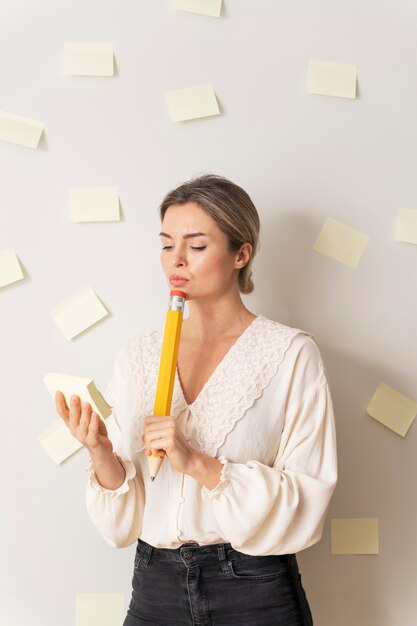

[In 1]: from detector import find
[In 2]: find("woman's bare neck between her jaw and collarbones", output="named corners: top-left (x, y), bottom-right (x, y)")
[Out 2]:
top-left (184, 294), bottom-right (256, 342)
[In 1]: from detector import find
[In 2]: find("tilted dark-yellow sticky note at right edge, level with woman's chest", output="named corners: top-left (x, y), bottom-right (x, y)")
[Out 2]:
top-left (366, 383), bottom-right (417, 437)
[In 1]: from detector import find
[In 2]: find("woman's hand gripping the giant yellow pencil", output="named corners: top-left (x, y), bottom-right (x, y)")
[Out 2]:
top-left (142, 415), bottom-right (198, 474)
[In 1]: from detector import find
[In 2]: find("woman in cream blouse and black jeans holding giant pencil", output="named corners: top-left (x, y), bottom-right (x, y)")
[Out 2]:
top-left (57, 175), bottom-right (336, 626)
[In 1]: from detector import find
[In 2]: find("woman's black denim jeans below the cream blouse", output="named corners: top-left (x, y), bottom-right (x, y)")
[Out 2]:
top-left (123, 539), bottom-right (313, 626)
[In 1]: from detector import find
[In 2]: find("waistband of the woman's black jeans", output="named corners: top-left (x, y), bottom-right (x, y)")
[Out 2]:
top-left (137, 539), bottom-right (296, 565)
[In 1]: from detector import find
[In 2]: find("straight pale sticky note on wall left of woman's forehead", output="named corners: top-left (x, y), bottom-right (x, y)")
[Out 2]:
top-left (69, 187), bottom-right (120, 222)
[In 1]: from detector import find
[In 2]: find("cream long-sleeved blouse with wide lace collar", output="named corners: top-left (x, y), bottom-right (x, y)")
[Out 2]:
top-left (86, 315), bottom-right (337, 555)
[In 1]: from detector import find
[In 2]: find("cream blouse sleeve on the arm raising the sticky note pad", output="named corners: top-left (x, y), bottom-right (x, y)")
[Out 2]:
top-left (86, 346), bottom-right (145, 548)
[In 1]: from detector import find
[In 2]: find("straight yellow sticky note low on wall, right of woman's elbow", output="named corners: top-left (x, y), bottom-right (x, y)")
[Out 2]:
top-left (331, 518), bottom-right (379, 554)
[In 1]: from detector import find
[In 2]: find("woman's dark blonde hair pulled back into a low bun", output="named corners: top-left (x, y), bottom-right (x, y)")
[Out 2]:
top-left (159, 174), bottom-right (260, 294)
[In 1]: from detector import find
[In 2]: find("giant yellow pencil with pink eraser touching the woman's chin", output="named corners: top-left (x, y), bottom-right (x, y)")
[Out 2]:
top-left (147, 290), bottom-right (186, 481)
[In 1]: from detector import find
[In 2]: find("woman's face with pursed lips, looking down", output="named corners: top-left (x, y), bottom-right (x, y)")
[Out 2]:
top-left (160, 202), bottom-right (244, 300)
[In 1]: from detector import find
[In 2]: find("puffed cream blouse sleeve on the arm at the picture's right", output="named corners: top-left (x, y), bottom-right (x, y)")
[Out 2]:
top-left (202, 338), bottom-right (337, 555)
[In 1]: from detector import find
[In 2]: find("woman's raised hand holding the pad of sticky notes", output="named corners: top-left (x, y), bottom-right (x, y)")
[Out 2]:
top-left (55, 391), bottom-right (113, 456)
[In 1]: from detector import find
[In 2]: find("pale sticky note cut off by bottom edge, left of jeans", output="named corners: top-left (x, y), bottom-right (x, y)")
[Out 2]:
top-left (75, 593), bottom-right (124, 626)
